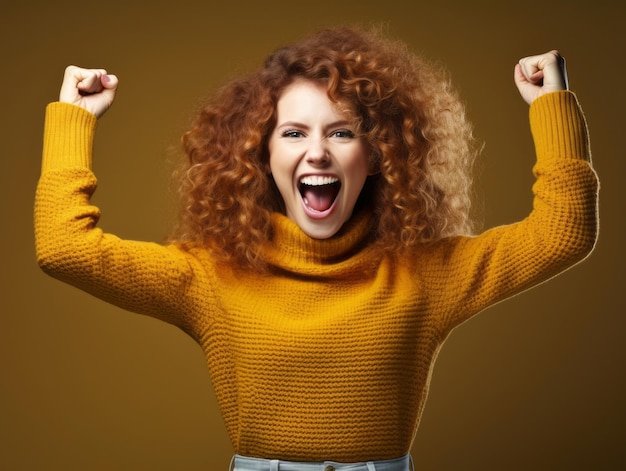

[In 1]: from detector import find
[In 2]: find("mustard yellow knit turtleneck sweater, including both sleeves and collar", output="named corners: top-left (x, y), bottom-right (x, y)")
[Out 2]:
top-left (36, 92), bottom-right (597, 462)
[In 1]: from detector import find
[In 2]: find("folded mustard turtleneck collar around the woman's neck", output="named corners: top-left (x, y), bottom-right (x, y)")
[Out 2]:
top-left (262, 210), bottom-right (375, 278)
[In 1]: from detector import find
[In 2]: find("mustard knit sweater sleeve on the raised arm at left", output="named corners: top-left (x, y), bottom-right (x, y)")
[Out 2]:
top-left (35, 103), bottom-right (210, 332)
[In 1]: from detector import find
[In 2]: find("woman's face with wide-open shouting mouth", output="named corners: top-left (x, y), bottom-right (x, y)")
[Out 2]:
top-left (269, 79), bottom-right (369, 239)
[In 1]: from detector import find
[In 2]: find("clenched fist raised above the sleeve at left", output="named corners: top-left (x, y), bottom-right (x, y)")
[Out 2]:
top-left (59, 65), bottom-right (118, 118)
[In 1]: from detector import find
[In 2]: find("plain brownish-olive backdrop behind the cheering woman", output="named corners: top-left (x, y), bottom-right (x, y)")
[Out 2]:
top-left (0, 0), bottom-right (626, 471)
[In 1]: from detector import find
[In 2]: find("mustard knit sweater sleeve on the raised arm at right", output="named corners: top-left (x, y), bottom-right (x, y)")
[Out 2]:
top-left (421, 91), bottom-right (598, 332)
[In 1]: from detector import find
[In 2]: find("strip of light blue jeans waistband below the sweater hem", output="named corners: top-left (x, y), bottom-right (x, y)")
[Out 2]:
top-left (230, 455), bottom-right (413, 471)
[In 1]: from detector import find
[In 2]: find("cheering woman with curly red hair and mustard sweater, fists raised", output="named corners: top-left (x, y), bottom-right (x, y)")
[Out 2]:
top-left (36, 28), bottom-right (597, 470)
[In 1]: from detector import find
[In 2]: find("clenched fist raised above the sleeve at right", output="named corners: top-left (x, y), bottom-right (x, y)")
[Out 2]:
top-left (515, 50), bottom-right (567, 105)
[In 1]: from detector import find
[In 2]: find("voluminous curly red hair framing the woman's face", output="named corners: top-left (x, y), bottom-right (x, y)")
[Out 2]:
top-left (173, 28), bottom-right (476, 267)
